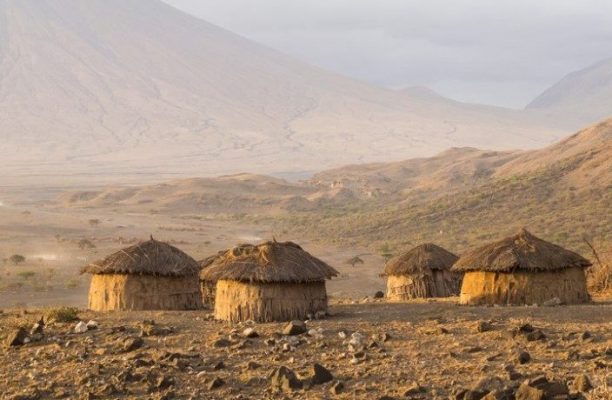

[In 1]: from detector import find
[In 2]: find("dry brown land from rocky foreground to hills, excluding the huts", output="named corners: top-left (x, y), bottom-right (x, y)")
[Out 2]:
top-left (0, 122), bottom-right (612, 399)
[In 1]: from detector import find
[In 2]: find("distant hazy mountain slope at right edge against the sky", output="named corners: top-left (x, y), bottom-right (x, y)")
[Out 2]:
top-left (527, 58), bottom-right (612, 128)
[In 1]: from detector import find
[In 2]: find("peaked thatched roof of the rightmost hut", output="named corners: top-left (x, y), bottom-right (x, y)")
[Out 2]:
top-left (452, 229), bottom-right (591, 272)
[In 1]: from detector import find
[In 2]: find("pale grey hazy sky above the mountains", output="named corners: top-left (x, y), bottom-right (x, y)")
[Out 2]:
top-left (165, 0), bottom-right (612, 108)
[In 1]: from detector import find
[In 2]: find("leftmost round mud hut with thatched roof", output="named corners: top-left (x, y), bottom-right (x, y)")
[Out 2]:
top-left (81, 238), bottom-right (202, 311)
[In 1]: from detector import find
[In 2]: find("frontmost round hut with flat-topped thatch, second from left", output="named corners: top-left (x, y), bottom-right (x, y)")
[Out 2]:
top-left (200, 241), bottom-right (338, 322)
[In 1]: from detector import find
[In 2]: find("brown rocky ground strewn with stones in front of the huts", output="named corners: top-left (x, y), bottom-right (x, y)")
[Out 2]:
top-left (0, 300), bottom-right (612, 400)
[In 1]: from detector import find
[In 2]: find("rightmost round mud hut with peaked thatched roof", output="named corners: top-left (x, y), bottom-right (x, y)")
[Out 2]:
top-left (452, 229), bottom-right (591, 305)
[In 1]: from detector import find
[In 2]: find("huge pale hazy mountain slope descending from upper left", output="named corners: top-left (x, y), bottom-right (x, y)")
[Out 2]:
top-left (0, 0), bottom-right (564, 184)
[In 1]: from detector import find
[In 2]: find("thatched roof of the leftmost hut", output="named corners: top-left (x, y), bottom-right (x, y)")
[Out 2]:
top-left (81, 238), bottom-right (200, 276)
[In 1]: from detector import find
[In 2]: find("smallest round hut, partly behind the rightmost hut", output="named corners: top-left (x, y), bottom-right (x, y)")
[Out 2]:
top-left (383, 243), bottom-right (461, 301)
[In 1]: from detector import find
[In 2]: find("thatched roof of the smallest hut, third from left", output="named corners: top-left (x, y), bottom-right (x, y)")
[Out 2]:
top-left (383, 243), bottom-right (458, 276)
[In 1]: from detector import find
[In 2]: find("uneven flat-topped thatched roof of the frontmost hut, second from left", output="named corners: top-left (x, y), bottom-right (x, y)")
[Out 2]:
top-left (200, 241), bottom-right (338, 283)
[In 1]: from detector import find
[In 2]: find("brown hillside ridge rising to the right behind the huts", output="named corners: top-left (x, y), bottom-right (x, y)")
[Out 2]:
top-left (55, 120), bottom-right (612, 251)
